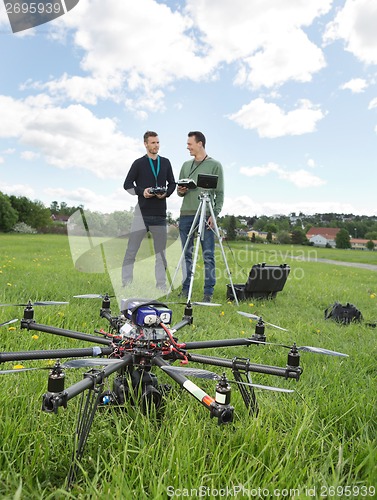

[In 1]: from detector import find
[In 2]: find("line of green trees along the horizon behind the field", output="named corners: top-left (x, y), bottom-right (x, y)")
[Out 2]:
top-left (0, 192), bottom-right (377, 248)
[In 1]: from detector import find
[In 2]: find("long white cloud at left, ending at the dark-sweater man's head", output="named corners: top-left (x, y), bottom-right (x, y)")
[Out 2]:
top-left (0, 96), bottom-right (144, 178)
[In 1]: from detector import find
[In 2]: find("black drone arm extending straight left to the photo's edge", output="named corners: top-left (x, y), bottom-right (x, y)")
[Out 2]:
top-left (0, 346), bottom-right (114, 363)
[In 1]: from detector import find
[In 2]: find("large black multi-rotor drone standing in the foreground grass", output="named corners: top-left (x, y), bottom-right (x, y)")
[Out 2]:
top-left (0, 294), bottom-right (347, 484)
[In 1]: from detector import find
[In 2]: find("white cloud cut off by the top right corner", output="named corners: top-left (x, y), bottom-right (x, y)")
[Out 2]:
top-left (324, 0), bottom-right (377, 64)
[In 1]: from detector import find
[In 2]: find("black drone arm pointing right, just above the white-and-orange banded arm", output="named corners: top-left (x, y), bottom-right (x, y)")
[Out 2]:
top-left (187, 353), bottom-right (301, 380)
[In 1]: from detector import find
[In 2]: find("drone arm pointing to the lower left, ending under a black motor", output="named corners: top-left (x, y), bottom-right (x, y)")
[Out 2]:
top-left (42, 354), bottom-right (132, 413)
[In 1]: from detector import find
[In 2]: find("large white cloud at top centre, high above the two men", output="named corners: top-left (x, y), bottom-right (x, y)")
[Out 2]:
top-left (43, 0), bottom-right (214, 113)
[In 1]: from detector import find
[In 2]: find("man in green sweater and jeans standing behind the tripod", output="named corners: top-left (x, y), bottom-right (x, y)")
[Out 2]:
top-left (177, 131), bottom-right (224, 302)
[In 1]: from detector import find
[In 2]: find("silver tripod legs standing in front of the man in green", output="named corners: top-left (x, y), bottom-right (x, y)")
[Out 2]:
top-left (167, 190), bottom-right (238, 305)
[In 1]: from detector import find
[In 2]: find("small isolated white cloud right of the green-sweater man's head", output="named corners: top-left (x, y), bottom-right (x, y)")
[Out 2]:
top-left (229, 98), bottom-right (325, 138)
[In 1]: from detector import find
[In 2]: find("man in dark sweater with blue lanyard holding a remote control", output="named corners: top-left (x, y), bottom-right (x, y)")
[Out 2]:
top-left (122, 131), bottom-right (175, 289)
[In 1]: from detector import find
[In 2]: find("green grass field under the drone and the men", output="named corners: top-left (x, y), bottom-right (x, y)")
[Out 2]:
top-left (0, 235), bottom-right (377, 500)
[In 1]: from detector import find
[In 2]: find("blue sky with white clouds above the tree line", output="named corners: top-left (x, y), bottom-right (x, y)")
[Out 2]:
top-left (0, 0), bottom-right (377, 219)
